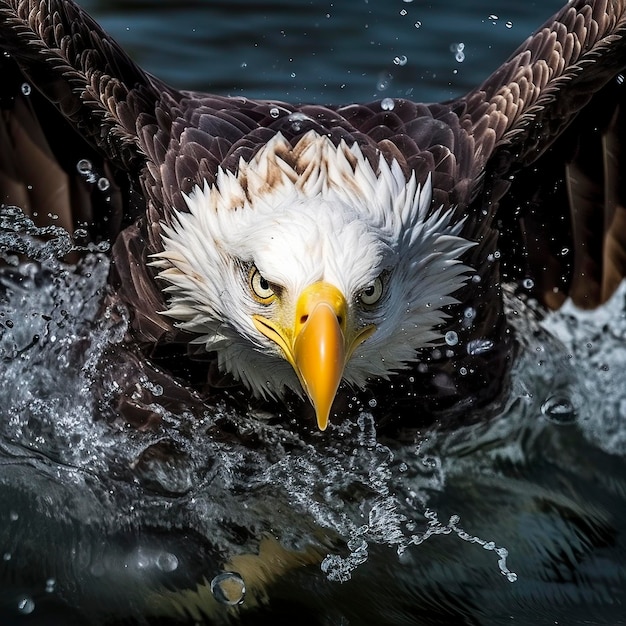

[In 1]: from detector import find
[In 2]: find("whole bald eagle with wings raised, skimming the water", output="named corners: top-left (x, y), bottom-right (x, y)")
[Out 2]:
top-left (0, 0), bottom-right (626, 429)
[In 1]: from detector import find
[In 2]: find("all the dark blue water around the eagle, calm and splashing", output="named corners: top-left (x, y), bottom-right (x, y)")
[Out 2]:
top-left (0, 0), bottom-right (626, 626)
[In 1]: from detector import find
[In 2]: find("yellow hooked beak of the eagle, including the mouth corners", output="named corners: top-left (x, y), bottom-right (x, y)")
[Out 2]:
top-left (253, 282), bottom-right (375, 430)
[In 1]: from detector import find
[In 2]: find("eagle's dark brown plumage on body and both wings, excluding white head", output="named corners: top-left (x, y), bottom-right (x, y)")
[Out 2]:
top-left (0, 0), bottom-right (626, 426)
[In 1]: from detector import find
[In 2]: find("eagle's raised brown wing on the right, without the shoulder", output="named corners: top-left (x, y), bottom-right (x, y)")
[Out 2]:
top-left (460, 0), bottom-right (626, 308)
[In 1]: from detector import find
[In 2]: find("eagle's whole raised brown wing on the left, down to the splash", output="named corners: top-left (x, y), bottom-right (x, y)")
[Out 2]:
top-left (0, 0), bottom-right (167, 243)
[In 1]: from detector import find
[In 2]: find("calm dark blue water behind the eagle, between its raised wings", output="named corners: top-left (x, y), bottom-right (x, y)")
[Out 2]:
top-left (82, 0), bottom-right (562, 104)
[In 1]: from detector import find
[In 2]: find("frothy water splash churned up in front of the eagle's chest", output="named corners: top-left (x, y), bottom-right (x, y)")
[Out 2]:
top-left (0, 213), bottom-right (626, 611)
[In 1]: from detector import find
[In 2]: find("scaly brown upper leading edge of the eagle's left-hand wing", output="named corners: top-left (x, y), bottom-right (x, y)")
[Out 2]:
top-left (0, 0), bottom-right (173, 169)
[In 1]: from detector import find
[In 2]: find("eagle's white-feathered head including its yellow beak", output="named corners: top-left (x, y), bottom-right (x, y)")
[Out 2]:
top-left (153, 131), bottom-right (474, 430)
